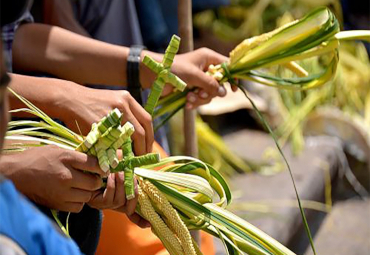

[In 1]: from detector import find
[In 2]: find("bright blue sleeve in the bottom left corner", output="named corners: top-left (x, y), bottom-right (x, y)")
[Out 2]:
top-left (0, 178), bottom-right (81, 255)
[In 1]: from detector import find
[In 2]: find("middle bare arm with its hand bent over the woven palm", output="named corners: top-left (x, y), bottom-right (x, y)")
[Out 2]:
top-left (9, 74), bottom-right (154, 155)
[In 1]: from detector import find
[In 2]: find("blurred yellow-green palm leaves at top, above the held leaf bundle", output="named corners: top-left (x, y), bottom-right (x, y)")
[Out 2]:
top-left (194, 0), bottom-right (343, 42)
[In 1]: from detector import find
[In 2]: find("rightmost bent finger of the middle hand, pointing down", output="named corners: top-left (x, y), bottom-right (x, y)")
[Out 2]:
top-left (130, 98), bottom-right (154, 153)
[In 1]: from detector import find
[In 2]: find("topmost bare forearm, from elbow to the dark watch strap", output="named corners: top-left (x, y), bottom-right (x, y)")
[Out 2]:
top-left (13, 24), bottom-right (129, 85)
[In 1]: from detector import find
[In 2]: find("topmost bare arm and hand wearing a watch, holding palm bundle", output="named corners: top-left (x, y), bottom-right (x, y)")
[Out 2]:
top-left (13, 24), bottom-right (227, 105)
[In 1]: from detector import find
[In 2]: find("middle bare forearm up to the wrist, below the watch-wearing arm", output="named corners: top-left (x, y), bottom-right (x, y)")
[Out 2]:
top-left (9, 74), bottom-right (73, 119)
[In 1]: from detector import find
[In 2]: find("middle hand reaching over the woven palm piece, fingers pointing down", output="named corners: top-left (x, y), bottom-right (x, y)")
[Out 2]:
top-left (61, 84), bottom-right (154, 155)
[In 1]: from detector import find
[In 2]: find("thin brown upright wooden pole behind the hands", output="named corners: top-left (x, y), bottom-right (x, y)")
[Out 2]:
top-left (177, 0), bottom-right (200, 246)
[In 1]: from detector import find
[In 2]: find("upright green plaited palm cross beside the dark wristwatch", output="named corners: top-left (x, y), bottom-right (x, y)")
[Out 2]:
top-left (143, 35), bottom-right (186, 115)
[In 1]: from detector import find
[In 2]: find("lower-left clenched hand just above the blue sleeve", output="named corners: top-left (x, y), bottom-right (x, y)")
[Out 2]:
top-left (0, 145), bottom-right (105, 212)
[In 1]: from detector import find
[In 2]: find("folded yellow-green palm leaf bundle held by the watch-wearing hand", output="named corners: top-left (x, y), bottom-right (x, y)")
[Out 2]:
top-left (153, 7), bottom-right (370, 128)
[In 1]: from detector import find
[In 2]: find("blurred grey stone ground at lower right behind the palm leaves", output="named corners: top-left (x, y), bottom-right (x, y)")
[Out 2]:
top-left (211, 129), bottom-right (370, 255)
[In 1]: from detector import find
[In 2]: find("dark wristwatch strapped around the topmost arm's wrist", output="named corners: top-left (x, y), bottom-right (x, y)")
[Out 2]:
top-left (126, 45), bottom-right (146, 105)
